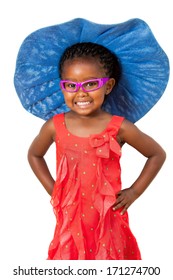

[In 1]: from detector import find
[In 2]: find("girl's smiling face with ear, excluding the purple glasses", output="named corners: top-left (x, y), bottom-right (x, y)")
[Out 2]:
top-left (61, 58), bottom-right (115, 116)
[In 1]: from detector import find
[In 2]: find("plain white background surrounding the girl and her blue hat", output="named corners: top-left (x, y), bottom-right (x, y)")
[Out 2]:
top-left (0, 0), bottom-right (173, 279)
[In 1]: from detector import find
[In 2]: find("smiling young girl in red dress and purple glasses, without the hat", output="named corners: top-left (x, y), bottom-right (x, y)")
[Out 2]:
top-left (28, 43), bottom-right (166, 260)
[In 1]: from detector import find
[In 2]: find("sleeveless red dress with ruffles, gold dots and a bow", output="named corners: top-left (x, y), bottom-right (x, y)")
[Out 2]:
top-left (48, 114), bottom-right (141, 260)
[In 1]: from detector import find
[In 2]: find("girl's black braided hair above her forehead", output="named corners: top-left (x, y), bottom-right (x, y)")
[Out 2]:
top-left (59, 42), bottom-right (121, 84)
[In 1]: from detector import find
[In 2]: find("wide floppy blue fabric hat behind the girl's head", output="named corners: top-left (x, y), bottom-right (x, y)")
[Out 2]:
top-left (14, 18), bottom-right (169, 122)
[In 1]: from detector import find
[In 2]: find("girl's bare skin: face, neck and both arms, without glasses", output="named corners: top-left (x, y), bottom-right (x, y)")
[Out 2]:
top-left (28, 58), bottom-right (166, 214)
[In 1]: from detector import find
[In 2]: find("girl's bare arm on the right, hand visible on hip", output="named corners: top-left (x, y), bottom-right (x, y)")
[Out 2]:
top-left (113, 120), bottom-right (166, 214)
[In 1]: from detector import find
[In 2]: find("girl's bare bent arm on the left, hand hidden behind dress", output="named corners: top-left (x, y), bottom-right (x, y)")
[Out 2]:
top-left (28, 119), bottom-right (55, 195)
